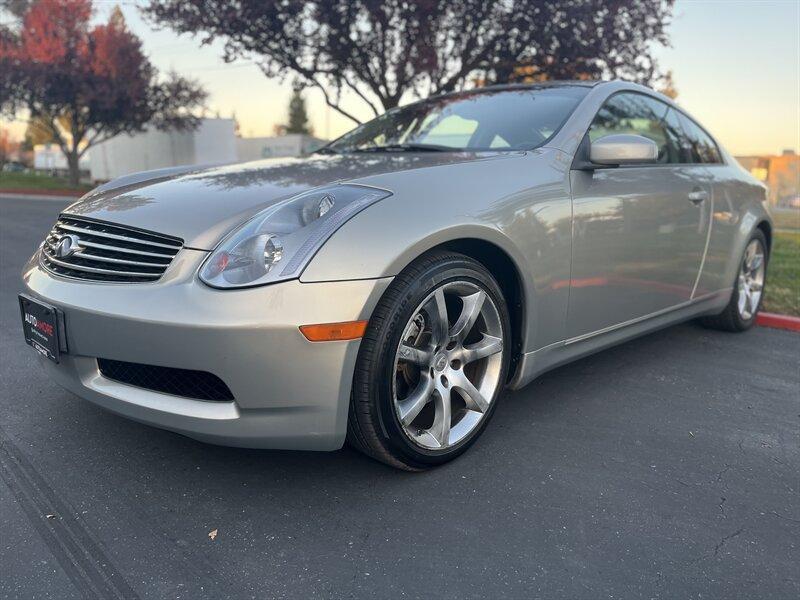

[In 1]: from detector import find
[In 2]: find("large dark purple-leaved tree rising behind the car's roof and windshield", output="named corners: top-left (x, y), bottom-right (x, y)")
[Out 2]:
top-left (143, 0), bottom-right (674, 116)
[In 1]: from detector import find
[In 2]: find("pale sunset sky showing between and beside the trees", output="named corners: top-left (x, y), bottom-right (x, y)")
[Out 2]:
top-left (3, 0), bottom-right (800, 156)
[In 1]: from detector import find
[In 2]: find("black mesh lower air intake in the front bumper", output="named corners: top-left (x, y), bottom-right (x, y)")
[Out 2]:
top-left (97, 358), bottom-right (233, 401)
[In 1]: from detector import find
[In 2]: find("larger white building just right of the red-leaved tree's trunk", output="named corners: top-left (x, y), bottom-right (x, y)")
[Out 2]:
top-left (89, 119), bottom-right (237, 181)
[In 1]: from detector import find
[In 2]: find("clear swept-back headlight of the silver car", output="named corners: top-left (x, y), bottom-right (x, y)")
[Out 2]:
top-left (200, 184), bottom-right (391, 288)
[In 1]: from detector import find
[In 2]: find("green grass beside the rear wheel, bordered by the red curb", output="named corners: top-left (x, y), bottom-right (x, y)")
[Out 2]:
top-left (763, 231), bottom-right (800, 317)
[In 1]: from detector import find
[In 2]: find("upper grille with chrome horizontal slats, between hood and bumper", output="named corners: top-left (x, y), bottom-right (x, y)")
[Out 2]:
top-left (41, 215), bottom-right (183, 283)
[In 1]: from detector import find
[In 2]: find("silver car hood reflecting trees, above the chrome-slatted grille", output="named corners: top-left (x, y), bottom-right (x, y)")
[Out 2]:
top-left (64, 152), bottom-right (510, 250)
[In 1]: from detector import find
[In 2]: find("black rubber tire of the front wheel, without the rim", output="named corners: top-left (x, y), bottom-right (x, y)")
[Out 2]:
top-left (347, 251), bottom-right (511, 471)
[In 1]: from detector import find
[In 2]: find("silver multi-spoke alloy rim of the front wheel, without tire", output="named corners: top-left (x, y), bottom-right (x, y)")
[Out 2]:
top-left (393, 281), bottom-right (504, 450)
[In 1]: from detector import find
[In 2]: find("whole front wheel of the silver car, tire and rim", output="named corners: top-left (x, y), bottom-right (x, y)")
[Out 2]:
top-left (348, 252), bottom-right (510, 470)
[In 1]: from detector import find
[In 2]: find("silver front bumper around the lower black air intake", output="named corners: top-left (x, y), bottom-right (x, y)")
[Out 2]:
top-left (23, 249), bottom-right (391, 450)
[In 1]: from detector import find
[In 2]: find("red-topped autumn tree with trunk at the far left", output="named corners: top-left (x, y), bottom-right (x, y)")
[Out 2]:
top-left (0, 0), bottom-right (206, 186)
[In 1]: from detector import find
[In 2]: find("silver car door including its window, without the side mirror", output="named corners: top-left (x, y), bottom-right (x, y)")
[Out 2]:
top-left (566, 92), bottom-right (710, 339)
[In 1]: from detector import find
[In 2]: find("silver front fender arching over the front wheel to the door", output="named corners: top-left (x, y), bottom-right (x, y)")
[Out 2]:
top-left (301, 150), bottom-right (572, 351)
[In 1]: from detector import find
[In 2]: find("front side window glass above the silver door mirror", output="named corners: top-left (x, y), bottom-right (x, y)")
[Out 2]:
top-left (589, 93), bottom-right (681, 164)
